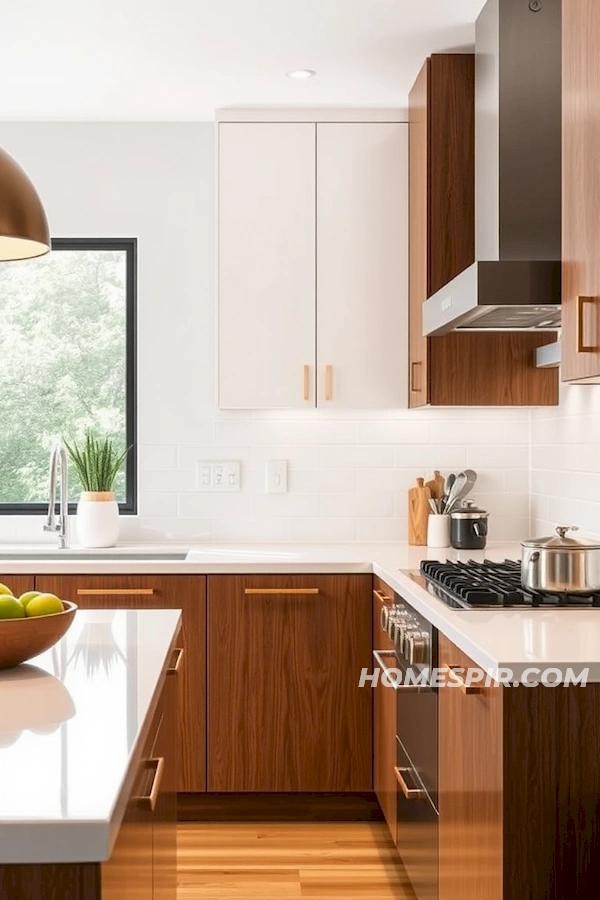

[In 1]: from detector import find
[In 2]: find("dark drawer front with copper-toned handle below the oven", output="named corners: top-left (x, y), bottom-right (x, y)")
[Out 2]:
top-left (396, 739), bottom-right (439, 900)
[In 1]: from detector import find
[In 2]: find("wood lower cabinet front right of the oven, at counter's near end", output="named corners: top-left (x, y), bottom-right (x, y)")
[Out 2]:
top-left (439, 635), bottom-right (504, 900)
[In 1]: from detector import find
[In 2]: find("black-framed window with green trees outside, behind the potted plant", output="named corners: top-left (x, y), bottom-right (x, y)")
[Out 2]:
top-left (0, 238), bottom-right (137, 514)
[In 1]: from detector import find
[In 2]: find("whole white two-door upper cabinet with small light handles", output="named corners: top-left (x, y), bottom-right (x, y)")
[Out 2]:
top-left (218, 114), bottom-right (408, 409)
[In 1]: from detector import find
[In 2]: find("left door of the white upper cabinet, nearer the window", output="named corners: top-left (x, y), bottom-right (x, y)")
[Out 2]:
top-left (218, 122), bottom-right (316, 409)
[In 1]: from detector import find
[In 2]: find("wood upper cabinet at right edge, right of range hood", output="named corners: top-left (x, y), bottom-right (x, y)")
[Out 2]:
top-left (561, 0), bottom-right (600, 383)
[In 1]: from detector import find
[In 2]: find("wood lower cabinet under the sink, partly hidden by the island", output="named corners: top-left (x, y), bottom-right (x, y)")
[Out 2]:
top-left (35, 575), bottom-right (206, 792)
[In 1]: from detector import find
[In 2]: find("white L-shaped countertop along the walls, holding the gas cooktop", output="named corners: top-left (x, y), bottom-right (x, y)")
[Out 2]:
top-left (0, 542), bottom-right (600, 681)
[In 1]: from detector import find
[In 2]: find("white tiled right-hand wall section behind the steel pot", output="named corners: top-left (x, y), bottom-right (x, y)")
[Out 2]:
top-left (531, 385), bottom-right (600, 535)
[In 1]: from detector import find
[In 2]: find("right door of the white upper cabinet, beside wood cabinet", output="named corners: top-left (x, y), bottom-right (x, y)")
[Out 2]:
top-left (317, 122), bottom-right (408, 408)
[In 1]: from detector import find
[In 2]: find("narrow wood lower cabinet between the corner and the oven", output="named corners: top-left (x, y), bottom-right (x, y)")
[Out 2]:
top-left (372, 576), bottom-right (398, 841)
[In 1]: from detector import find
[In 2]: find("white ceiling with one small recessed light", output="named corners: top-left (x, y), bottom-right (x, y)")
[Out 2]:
top-left (0, 0), bottom-right (484, 121)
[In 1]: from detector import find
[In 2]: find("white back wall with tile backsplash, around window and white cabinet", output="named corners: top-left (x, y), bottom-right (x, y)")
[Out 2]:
top-left (0, 123), bottom-right (530, 541)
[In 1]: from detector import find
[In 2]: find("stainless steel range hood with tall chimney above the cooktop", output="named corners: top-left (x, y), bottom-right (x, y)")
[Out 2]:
top-left (423, 0), bottom-right (561, 335)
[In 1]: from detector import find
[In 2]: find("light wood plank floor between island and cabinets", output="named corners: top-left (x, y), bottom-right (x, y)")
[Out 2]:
top-left (178, 822), bottom-right (414, 900)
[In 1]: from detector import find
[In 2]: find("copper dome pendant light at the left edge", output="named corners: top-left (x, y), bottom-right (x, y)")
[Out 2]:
top-left (0, 148), bottom-right (50, 261)
